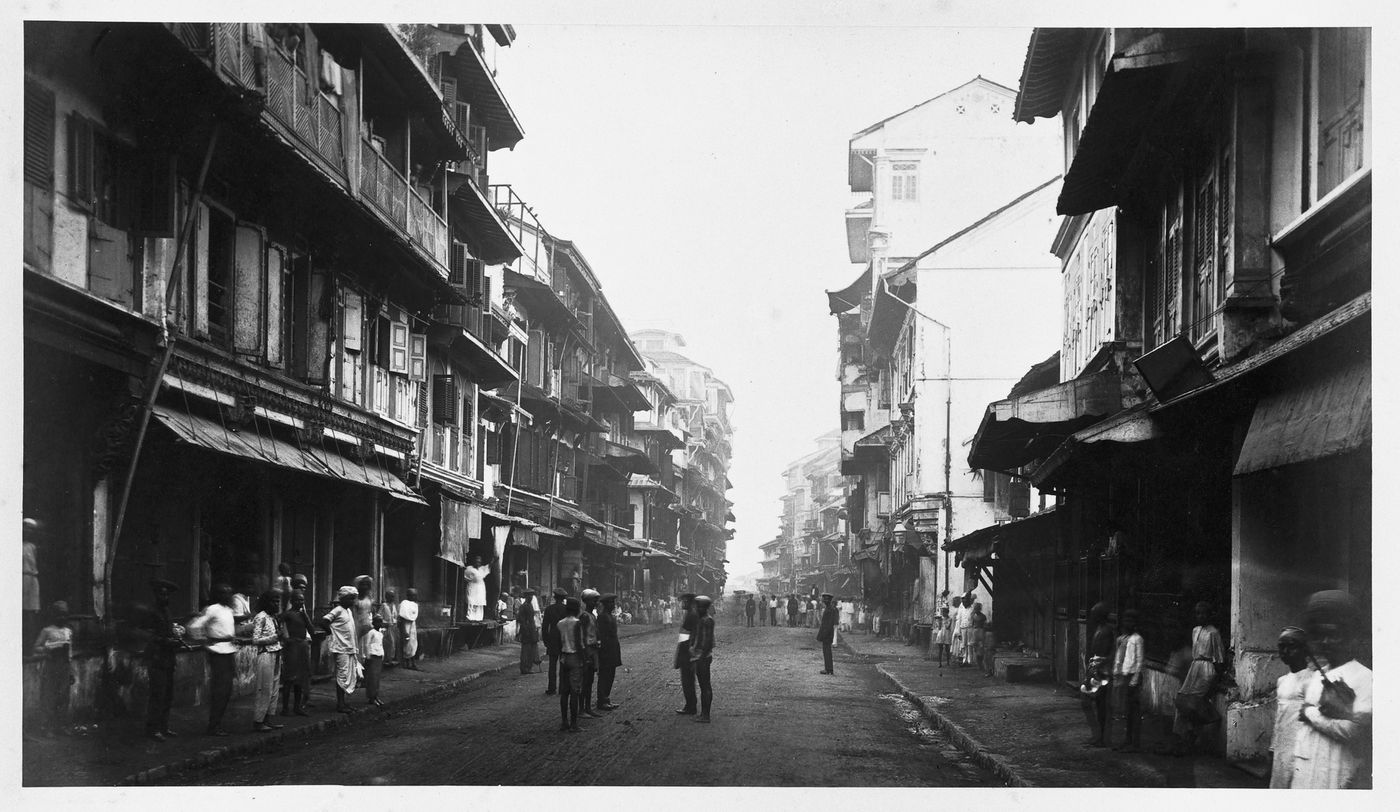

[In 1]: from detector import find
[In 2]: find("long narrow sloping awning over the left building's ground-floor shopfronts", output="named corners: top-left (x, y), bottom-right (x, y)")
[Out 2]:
top-left (151, 405), bottom-right (427, 505)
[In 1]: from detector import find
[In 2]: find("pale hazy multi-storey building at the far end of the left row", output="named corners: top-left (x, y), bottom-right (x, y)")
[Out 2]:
top-left (631, 329), bottom-right (734, 601)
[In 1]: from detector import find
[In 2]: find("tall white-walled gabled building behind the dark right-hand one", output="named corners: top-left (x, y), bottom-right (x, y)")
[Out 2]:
top-left (827, 77), bottom-right (1060, 633)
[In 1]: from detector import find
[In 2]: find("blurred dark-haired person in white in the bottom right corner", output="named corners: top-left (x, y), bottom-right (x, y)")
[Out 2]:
top-left (1292, 589), bottom-right (1375, 790)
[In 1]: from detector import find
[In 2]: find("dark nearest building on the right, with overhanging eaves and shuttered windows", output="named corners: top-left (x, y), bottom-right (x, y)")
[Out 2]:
top-left (972, 28), bottom-right (1375, 759)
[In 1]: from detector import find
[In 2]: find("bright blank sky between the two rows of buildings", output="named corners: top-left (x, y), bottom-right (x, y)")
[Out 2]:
top-left (490, 24), bottom-right (1036, 574)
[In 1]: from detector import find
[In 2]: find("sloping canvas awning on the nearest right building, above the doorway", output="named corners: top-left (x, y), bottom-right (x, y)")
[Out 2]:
top-left (1235, 357), bottom-right (1371, 476)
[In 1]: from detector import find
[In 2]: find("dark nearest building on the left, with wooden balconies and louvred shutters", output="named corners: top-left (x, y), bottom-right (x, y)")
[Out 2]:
top-left (24, 22), bottom-right (534, 708)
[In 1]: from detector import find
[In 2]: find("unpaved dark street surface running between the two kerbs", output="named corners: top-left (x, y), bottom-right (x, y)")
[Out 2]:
top-left (175, 626), bottom-right (998, 787)
